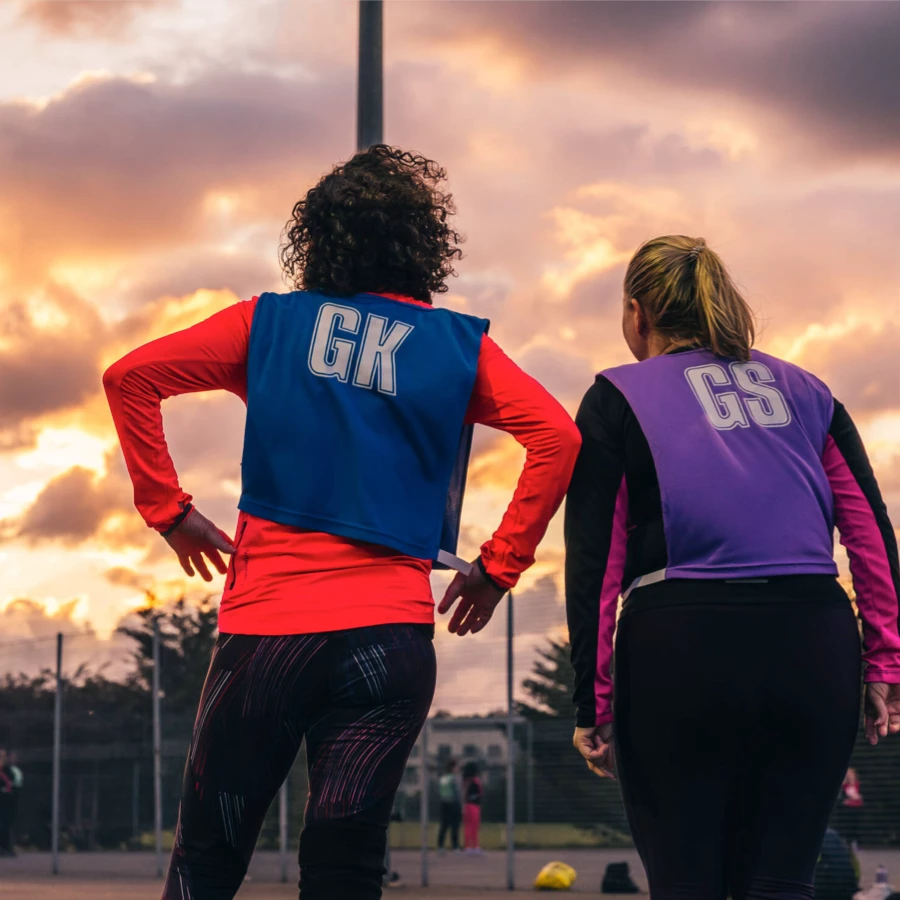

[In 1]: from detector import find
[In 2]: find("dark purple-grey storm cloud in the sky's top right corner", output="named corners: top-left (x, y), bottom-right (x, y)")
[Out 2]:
top-left (413, 0), bottom-right (900, 156)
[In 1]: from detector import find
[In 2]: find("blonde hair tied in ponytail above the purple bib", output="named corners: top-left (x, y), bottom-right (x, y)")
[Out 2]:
top-left (625, 235), bottom-right (756, 360)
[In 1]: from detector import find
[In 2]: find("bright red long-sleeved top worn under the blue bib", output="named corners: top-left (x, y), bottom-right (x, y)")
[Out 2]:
top-left (103, 298), bottom-right (581, 634)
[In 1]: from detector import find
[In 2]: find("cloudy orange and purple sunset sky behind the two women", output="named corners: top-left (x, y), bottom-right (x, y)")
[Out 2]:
top-left (0, 0), bottom-right (900, 704)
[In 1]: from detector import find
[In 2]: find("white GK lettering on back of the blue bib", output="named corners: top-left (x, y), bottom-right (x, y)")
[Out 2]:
top-left (309, 303), bottom-right (413, 395)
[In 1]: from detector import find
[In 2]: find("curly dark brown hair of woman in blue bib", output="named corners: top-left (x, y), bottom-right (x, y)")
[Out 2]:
top-left (280, 144), bottom-right (463, 303)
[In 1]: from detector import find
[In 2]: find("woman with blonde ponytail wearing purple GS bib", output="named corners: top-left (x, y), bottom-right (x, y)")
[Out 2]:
top-left (565, 235), bottom-right (900, 900)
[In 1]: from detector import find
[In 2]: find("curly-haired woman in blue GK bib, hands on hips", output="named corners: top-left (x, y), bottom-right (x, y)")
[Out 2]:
top-left (104, 145), bottom-right (580, 900)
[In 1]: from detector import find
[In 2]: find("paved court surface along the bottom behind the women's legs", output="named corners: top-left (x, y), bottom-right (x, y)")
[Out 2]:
top-left (0, 848), bottom-right (900, 900)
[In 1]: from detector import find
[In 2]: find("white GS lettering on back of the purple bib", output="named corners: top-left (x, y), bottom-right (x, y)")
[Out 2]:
top-left (684, 361), bottom-right (791, 431)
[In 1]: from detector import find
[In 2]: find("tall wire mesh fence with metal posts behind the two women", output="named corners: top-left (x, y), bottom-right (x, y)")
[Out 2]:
top-left (0, 583), bottom-right (900, 891)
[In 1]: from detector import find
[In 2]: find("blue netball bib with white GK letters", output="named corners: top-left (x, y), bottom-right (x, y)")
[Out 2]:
top-left (238, 291), bottom-right (488, 559)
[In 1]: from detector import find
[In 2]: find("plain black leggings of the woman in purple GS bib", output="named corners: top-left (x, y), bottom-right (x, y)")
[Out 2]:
top-left (615, 579), bottom-right (861, 900)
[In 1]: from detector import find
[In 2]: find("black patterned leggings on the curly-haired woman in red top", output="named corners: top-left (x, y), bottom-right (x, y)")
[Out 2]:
top-left (163, 625), bottom-right (435, 900)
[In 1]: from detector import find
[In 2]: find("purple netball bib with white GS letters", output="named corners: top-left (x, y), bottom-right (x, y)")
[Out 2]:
top-left (602, 350), bottom-right (837, 580)
